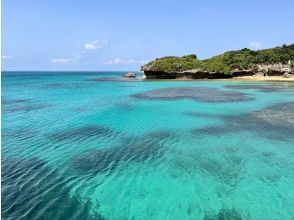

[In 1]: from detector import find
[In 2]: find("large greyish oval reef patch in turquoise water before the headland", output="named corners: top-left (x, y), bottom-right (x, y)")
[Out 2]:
top-left (132, 87), bottom-right (253, 102)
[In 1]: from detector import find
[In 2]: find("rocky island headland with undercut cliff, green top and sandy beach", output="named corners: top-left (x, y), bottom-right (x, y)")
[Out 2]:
top-left (141, 44), bottom-right (294, 80)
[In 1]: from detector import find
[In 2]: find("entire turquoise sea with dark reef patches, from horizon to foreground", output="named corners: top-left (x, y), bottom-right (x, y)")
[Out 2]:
top-left (2, 72), bottom-right (294, 219)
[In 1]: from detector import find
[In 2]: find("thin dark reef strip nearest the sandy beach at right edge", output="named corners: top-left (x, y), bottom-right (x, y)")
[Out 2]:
top-left (224, 84), bottom-right (293, 92)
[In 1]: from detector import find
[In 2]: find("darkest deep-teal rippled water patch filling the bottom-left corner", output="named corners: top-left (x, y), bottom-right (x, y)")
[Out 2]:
top-left (1, 158), bottom-right (103, 220)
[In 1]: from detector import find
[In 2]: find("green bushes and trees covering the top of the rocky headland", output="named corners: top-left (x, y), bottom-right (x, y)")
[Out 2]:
top-left (142, 44), bottom-right (294, 74)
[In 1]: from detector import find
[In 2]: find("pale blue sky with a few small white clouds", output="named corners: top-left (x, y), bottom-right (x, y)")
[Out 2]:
top-left (1, 0), bottom-right (294, 71)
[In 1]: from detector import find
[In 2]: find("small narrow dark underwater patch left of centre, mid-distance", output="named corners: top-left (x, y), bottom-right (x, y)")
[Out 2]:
top-left (48, 125), bottom-right (114, 141)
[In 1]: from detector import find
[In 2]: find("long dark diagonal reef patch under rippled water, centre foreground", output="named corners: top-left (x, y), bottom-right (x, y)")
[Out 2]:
top-left (72, 132), bottom-right (172, 174)
